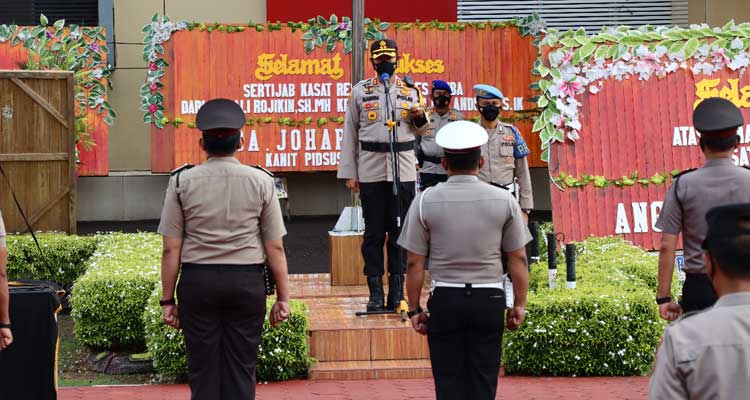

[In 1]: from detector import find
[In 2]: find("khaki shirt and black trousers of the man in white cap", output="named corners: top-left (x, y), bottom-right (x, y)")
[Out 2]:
top-left (398, 122), bottom-right (531, 399)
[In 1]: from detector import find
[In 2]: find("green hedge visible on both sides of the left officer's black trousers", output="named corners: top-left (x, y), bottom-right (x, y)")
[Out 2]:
top-left (143, 288), bottom-right (312, 381)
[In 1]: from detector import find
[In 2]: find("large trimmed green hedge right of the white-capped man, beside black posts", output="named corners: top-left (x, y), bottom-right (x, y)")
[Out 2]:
top-left (503, 237), bottom-right (680, 376)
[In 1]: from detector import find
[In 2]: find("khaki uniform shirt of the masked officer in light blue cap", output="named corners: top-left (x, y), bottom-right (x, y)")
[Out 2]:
top-left (479, 121), bottom-right (534, 210)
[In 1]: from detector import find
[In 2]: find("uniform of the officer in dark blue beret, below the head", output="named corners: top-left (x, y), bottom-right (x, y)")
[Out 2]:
top-left (417, 108), bottom-right (464, 190)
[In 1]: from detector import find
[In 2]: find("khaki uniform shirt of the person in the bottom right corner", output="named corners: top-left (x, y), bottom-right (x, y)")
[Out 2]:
top-left (648, 290), bottom-right (750, 400)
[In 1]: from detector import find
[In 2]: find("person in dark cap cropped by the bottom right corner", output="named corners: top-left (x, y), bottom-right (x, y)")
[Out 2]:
top-left (648, 204), bottom-right (750, 400)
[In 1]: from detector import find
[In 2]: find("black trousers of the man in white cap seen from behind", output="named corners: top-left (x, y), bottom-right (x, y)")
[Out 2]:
top-left (427, 287), bottom-right (505, 400)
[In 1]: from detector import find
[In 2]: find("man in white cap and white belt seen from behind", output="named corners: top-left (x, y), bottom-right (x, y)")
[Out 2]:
top-left (398, 121), bottom-right (531, 400)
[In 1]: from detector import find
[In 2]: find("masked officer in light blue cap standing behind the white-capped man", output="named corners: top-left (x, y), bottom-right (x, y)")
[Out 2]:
top-left (474, 85), bottom-right (534, 219)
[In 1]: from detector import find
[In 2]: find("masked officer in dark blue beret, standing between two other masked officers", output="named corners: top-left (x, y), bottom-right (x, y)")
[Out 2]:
top-left (417, 80), bottom-right (464, 190)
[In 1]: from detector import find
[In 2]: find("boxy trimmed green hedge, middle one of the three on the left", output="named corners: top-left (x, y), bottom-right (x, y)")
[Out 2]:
top-left (71, 233), bottom-right (161, 349)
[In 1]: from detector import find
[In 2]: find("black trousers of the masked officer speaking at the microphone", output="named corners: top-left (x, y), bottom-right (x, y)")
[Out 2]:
top-left (359, 182), bottom-right (415, 276)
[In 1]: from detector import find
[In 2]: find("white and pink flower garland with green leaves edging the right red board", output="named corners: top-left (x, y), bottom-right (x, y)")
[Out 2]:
top-left (533, 21), bottom-right (750, 164)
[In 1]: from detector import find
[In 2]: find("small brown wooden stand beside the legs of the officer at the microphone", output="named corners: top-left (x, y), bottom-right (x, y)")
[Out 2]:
top-left (328, 231), bottom-right (388, 286)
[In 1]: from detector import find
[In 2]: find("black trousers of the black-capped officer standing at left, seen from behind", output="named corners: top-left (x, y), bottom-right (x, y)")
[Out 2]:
top-left (177, 264), bottom-right (266, 400)
